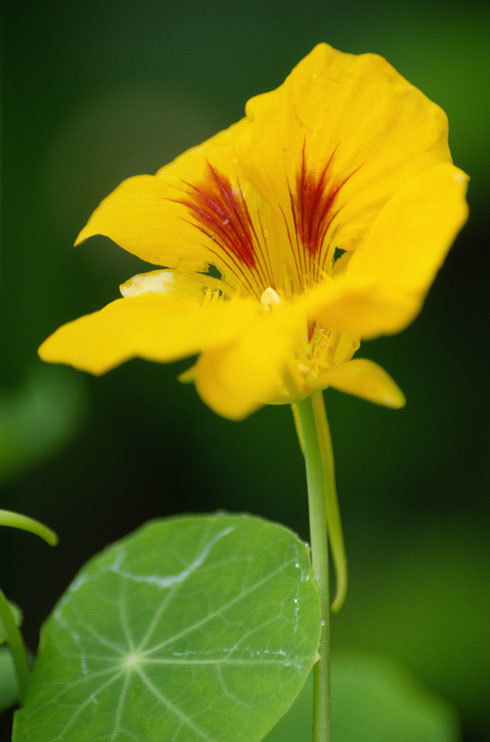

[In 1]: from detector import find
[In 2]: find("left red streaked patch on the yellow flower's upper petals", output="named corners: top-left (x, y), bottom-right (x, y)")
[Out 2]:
top-left (175, 163), bottom-right (257, 268)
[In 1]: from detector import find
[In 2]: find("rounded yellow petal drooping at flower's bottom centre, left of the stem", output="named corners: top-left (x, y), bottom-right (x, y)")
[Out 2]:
top-left (196, 309), bottom-right (302, 420)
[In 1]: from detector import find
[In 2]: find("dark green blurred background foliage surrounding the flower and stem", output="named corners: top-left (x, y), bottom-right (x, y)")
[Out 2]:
top-left (0, 0), bottom-right (490, 742)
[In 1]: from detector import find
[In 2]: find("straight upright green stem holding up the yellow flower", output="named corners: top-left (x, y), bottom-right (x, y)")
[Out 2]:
top-left (296, 393), bottom-right (330, 742)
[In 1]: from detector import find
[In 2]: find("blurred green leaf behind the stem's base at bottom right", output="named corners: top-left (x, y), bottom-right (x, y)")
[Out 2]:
top-left (264, 652), bottom-right (459, 742)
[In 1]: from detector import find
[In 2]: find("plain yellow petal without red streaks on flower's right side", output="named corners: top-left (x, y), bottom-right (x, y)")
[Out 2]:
top-left (308, 164), bottom-right (468, 338)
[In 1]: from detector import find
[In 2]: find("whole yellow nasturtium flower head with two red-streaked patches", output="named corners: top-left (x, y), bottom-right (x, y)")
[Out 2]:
top-left (40, 44), bottom-right (467, 419)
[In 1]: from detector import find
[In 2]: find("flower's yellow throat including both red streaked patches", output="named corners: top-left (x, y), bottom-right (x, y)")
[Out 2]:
top-left (173, 141), bottom-right (352, 300)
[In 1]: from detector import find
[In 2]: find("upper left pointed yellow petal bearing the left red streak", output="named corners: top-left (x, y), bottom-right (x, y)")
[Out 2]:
top-left (75, 120), bottom-right (268, 289)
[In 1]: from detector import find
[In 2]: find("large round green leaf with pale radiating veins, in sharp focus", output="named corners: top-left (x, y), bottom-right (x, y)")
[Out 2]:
top-left (14, 515), bottom-right (320, 742)
